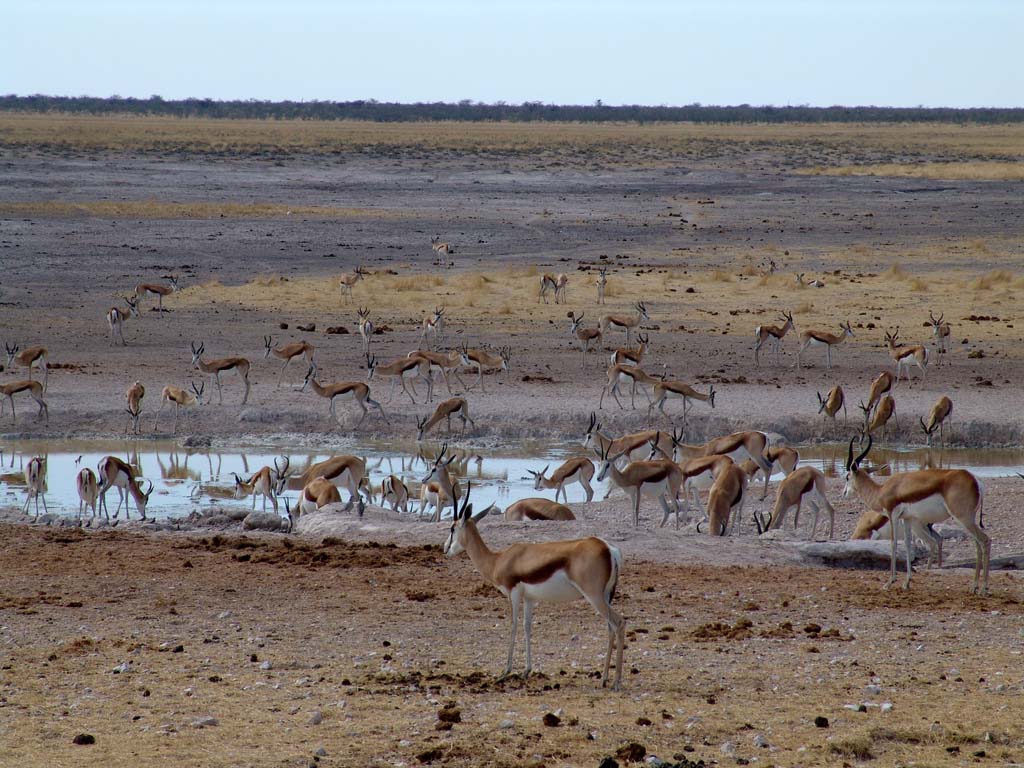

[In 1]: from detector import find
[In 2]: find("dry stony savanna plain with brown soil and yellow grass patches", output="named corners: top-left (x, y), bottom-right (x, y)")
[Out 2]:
top-left (0, 114), bottom-right (1024, 767)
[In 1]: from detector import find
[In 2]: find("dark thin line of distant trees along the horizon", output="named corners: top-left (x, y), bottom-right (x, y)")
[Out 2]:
top-left (0, 94), bottom-right (1024, 124)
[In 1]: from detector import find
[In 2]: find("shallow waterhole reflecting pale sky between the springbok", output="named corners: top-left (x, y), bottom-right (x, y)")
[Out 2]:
top-left (0, 440), bottom-right (1024, 517)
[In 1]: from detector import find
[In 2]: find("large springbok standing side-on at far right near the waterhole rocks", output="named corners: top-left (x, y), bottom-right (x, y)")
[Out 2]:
top-left (843, 435), bottom-right (992, 595)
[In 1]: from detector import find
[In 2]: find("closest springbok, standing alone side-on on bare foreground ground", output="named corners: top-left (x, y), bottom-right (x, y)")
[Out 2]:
top-left (444, 488), bottom-right (626, 690)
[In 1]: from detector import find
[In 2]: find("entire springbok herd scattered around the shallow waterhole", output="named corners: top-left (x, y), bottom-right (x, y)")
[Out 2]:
top-left (0, 257), bottom-right (990, 688)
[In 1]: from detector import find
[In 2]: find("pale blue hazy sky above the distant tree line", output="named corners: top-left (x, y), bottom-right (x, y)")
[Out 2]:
top-left (0, 0), bottom-right (1024, 106)
